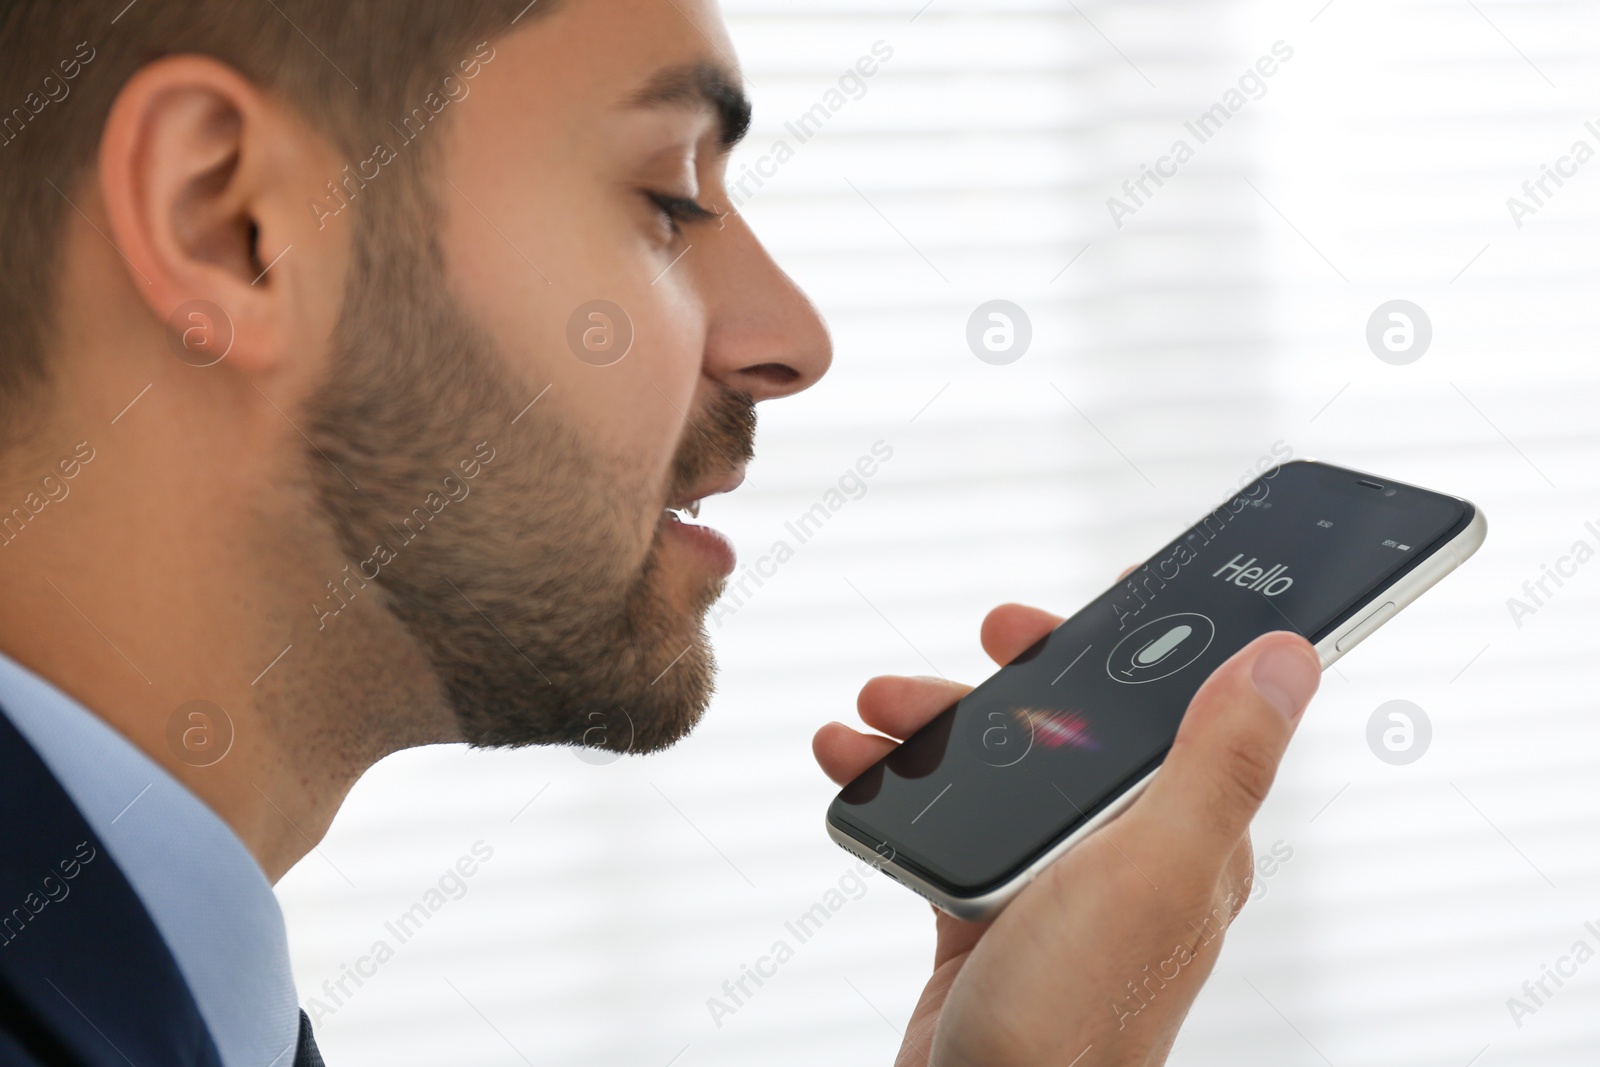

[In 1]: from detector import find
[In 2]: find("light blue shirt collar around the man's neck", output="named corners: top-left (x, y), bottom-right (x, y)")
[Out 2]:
top-left (0, 654), bottom-right (299, 1067)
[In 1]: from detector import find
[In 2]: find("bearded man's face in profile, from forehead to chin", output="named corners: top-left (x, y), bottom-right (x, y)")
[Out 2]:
top-left (300, 0), bottom-right (830, 750)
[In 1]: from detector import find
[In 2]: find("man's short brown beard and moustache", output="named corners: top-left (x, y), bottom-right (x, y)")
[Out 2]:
top-left (307, 174), bottom-right (755, 752)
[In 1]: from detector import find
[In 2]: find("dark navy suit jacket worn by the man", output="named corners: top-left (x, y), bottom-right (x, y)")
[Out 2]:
top-left (0, 703), bottom-right (322, 1067)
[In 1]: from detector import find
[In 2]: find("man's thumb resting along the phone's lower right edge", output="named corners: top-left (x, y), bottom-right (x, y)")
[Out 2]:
top-left (1128, 632), bottom-right (1322, 870)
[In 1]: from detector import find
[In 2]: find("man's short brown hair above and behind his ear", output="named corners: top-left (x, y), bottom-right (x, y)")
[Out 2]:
top-left (0, 0), bottom-right (557, 437)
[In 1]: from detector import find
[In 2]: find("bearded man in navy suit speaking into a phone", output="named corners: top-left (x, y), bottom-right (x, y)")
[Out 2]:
top-left (0, 0), bottom-right (1318, 1067)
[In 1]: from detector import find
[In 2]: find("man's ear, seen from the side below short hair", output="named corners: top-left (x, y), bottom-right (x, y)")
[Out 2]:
top-left (99, 56), bottom-right (346, 379)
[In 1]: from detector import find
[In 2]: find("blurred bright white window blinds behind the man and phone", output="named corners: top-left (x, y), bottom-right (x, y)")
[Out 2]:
top-left (278, 0), bottom-right (1600, 1067)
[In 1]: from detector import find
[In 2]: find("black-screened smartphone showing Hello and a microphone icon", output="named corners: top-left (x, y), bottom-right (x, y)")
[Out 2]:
top-left (827, 461), bottom-right (1488, 920)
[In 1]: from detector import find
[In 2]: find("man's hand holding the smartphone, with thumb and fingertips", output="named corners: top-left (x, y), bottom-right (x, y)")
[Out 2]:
top-left (813, 605), bottom-right (1322, 1067)
